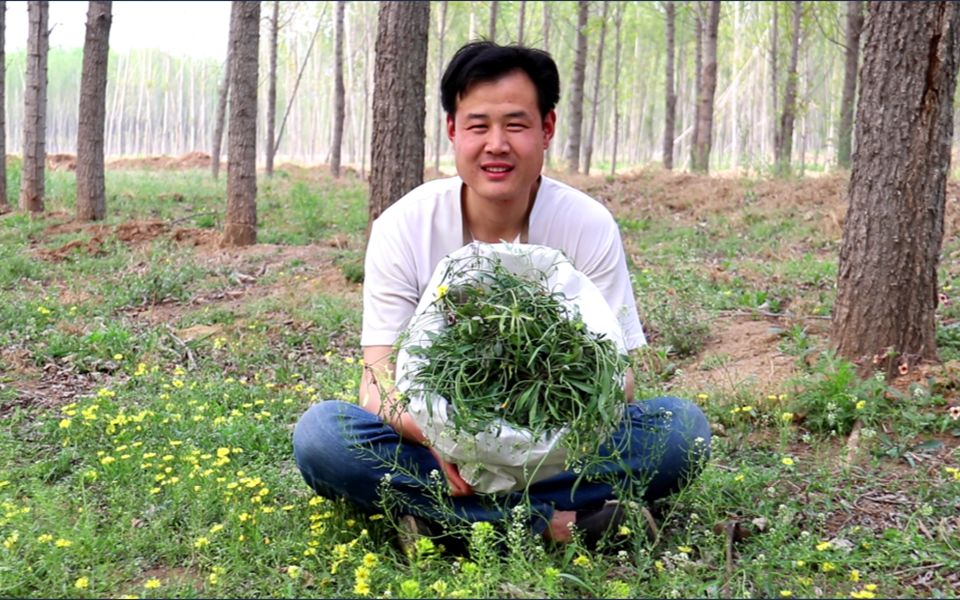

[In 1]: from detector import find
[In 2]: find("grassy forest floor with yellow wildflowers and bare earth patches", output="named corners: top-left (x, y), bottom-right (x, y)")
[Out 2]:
top-left (0, 162), bottom-right (960, 598)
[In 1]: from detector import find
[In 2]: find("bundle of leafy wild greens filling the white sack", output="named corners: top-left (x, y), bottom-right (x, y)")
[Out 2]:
top-left (409, 257), bottom-right (628, 460)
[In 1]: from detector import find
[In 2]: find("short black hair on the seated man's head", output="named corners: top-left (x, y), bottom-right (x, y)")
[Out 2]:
top-left (440, 41), bottom-right (560, 119)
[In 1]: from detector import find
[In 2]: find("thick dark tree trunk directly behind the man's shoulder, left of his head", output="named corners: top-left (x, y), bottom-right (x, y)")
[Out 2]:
top-left (367, 1), bottom-right (430, 233)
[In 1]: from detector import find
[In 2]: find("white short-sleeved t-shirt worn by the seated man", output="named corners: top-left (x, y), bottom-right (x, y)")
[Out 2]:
top-left (360, 177), bottom-right (646, 350)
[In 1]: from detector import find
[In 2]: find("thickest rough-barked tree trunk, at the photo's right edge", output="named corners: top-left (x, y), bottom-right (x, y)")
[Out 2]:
top-left (832, 2), bottom-right (960, 375)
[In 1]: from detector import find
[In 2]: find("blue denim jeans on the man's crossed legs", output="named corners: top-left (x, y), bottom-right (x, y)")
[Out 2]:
top-left (293, 397), bottom-right (710, 533)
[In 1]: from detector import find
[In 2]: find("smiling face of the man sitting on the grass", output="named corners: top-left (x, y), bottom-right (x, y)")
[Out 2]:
top-left (447, 71), bottom-right (557, 209)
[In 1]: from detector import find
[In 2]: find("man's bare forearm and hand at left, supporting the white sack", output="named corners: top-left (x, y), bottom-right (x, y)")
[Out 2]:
top-left (360, 346), bottom-right (473, 496)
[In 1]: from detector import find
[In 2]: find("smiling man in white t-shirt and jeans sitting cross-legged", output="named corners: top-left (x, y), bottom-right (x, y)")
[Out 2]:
top-left (294, 42), bottom-right (710, 545)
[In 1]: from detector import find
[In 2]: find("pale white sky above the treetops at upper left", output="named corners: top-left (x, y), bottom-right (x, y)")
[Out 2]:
top-left (6, 0), bottom-right (230, 60)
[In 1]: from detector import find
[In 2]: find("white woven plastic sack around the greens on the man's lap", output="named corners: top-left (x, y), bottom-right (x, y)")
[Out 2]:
top-left (397, 242), bottom-right (626, 493)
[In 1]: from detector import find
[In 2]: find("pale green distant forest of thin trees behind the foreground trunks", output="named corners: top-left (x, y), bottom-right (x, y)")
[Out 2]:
top-left (7, 2), bottom-right (876, 174)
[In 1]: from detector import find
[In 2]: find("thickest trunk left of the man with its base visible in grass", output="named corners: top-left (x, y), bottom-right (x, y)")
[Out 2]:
top-left (221, 0), bottom-right (260, 246)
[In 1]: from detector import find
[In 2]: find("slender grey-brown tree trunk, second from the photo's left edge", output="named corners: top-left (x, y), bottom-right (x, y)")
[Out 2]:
top-left (20, 0), bottom-right (50, 214)
